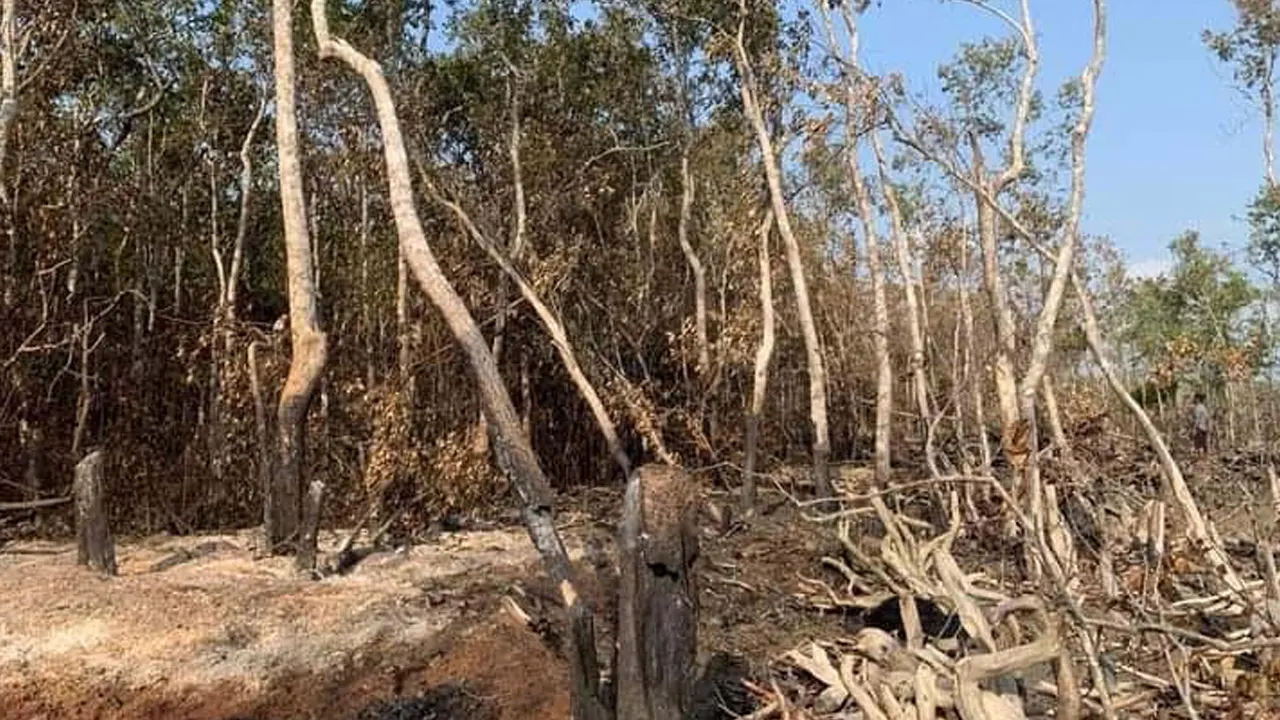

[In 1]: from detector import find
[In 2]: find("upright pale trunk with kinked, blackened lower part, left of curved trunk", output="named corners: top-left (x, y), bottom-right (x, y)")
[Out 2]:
top-left (266, 0), bottom-right (328, 570)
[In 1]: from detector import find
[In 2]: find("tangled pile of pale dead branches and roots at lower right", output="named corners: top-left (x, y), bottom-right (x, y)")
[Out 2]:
top-left (754, 468), bottom-right (1280, 720)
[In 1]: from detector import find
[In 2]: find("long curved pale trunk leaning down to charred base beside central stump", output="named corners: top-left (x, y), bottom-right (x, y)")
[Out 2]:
top-left (309, 11), bottom-right (608, 720)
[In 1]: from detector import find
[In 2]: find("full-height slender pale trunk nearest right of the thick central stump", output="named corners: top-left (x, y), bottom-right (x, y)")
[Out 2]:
top-left (735, 18), bottom-right (835, 497)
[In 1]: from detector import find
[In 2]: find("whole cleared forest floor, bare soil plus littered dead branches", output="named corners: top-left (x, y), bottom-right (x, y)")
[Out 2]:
top-left (0, 443), bottom-right (1280, 720)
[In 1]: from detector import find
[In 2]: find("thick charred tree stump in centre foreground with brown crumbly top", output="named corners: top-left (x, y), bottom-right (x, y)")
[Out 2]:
top-left (616, 465), bottom-right (698, 720)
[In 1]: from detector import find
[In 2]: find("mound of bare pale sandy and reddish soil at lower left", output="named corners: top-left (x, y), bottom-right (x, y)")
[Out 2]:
top-left (0, 528), bottom-right (588, 719)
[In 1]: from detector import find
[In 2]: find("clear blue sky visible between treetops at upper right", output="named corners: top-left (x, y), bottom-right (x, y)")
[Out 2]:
top-left (860, 0), bottom-right (1262, 274)
